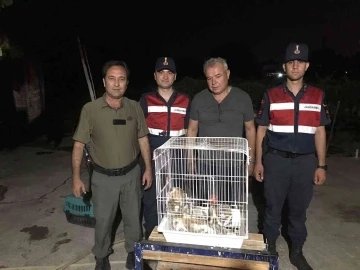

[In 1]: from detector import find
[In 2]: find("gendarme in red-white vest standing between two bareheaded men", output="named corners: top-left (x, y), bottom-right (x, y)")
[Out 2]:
top-left (139, 57), bottom-right (191, 239)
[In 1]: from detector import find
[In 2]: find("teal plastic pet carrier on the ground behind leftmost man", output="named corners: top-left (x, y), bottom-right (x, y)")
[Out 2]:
top-left (64, 194), bottom-right (96, 228)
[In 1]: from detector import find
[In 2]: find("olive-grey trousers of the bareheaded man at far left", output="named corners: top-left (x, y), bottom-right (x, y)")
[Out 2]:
top-left (91, 165), bottom-right (141, 258)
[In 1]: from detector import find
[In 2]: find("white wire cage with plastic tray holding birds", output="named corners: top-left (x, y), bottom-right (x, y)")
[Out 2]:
top-left (154, 137), bottom-right (249, 248)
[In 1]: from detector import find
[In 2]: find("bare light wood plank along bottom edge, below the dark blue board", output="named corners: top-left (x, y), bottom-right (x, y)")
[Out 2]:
top-left (143, 250), bottom-right (269, 270)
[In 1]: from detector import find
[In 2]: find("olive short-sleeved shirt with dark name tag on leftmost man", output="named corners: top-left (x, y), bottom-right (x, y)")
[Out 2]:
top-left (73, 95), bottom-right (149, 169)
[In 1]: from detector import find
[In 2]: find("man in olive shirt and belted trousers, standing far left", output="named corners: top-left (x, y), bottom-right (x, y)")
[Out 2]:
top-left (72, 61), bottom-right (152, 270)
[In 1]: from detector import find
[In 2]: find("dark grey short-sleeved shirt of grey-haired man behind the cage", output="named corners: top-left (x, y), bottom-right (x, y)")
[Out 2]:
top-left (190, 87), bottom-right (254, 137)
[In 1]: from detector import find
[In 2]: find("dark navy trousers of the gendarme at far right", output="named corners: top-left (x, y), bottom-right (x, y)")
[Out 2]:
top-left (263, 153), bottom-right (317, 245)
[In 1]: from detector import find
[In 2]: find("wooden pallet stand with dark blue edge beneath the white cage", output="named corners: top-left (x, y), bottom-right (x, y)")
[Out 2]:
top-left (135, 227), bottom-right (278, 270)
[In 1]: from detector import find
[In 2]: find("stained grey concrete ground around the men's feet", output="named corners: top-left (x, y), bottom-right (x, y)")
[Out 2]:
top-left (0, 138), bottom-right (360, 270)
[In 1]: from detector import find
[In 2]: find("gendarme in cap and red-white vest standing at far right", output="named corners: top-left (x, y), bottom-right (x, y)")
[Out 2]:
top-left (256, 43), bottom-right (331, 270)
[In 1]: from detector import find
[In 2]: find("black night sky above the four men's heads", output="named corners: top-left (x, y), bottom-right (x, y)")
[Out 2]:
top-left (0, 0), bottom-right (360, 73)
